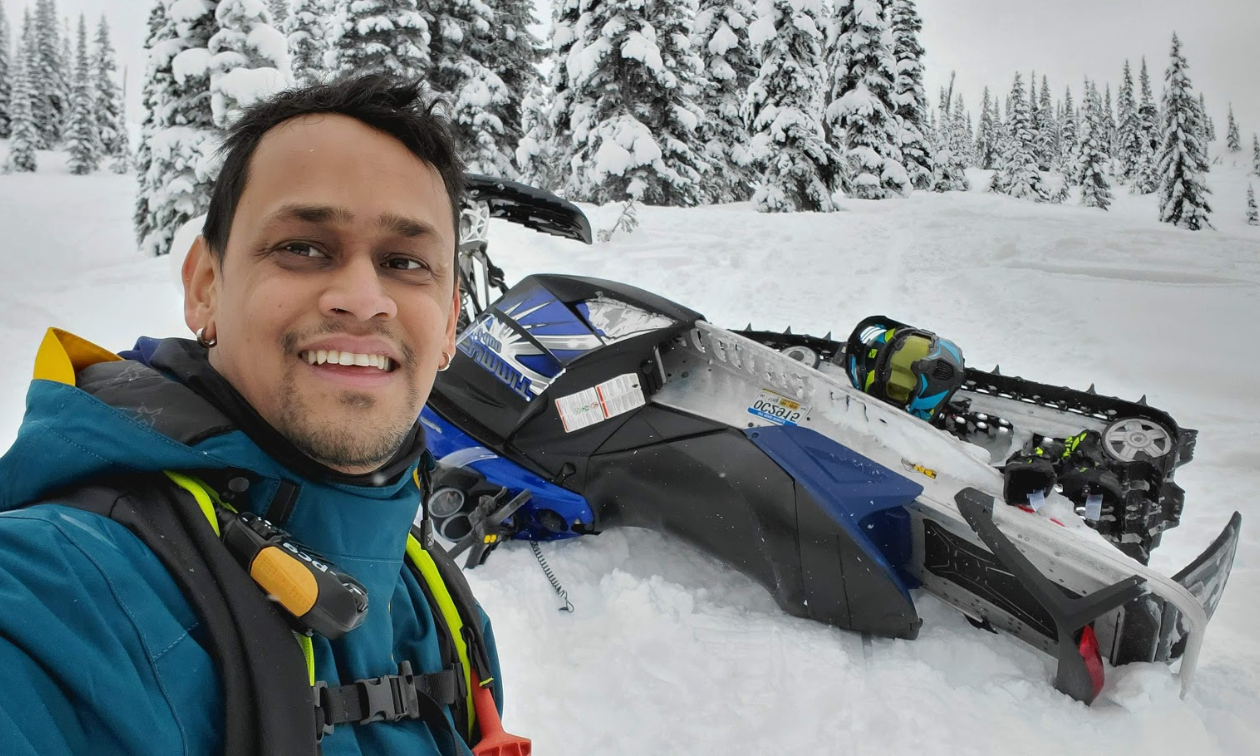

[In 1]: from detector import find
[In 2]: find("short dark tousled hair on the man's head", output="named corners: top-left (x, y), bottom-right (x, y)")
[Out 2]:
top-left (202, 73), bottom-right (465, 263)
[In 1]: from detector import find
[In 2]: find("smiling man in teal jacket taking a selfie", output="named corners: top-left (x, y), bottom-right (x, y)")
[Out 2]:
top-left (0, 76), bottom-right (511, 756)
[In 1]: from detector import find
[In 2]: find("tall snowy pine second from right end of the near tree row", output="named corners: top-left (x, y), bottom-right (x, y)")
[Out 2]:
top-left (825, 0), bottom-right (910, 199)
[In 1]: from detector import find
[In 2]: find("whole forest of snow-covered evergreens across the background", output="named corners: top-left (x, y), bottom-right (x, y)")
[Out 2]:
top-left (0, 0), bottom-right (1260, 255)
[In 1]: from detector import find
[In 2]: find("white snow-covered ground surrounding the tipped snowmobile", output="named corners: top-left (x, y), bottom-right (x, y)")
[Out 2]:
top-left (0, 144), bottom-right (1260, 756)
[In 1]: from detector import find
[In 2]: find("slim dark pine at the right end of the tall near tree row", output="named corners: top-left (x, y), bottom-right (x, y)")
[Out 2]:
top-left (890, 0), bottom-right (936, 189)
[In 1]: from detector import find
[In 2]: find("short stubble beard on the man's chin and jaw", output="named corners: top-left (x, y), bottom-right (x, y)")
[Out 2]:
top-left (276, 339), bottom-right (421, 471)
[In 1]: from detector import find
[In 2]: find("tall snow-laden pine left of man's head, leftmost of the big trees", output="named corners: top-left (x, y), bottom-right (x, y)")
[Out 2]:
top-left (135, 0), bottom-right (218, 256)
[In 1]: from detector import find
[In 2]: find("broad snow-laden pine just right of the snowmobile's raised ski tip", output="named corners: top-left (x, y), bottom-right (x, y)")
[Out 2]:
top-left (570, 3), bottom-right (709, 207)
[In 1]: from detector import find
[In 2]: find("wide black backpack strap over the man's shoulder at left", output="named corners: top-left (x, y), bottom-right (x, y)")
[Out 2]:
top-left (47, 474), bottom-right (318, 756)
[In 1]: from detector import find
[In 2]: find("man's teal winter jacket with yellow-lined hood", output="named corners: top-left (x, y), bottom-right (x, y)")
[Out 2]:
top-left (0, 330), bottom-right (501, 756)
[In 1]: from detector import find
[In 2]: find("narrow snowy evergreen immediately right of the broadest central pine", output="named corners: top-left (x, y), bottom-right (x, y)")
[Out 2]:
top-left (693, 0), bottom-right (757, 202)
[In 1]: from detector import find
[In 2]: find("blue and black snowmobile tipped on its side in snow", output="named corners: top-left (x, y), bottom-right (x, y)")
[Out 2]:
top-left (421, 176), bottom-right (1241, 703)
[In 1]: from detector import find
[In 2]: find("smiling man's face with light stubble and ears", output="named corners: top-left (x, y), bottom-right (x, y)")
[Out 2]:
top-left (184, 115), bottom-right (459, 473)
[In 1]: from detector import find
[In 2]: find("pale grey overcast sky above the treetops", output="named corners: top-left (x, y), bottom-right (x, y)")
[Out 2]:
top-left (9, 0), bottom-right (1260, 142)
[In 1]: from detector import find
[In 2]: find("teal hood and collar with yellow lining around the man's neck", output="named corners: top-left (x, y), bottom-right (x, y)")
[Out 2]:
top-left (0, 329), bottom-right (423, 602)
